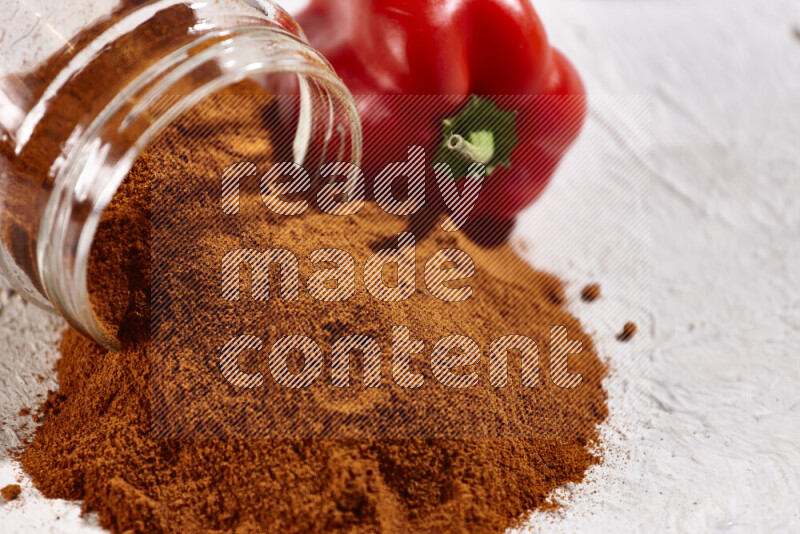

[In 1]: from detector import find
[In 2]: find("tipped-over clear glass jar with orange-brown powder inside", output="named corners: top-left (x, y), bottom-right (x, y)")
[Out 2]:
top-left (0, 0), bottom-right (361, 348)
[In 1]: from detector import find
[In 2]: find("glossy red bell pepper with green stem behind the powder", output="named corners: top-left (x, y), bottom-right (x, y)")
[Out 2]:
top-left (298, 0), bottom-right (586, 228)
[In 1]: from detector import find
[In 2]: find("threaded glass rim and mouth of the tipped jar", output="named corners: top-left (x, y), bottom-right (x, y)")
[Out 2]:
top-left (37, 27), bottom-right (361, 349)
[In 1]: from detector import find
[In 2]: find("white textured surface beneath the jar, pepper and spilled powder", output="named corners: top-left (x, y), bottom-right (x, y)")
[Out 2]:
top-left (0, 0), bottom-right (800, 532)
